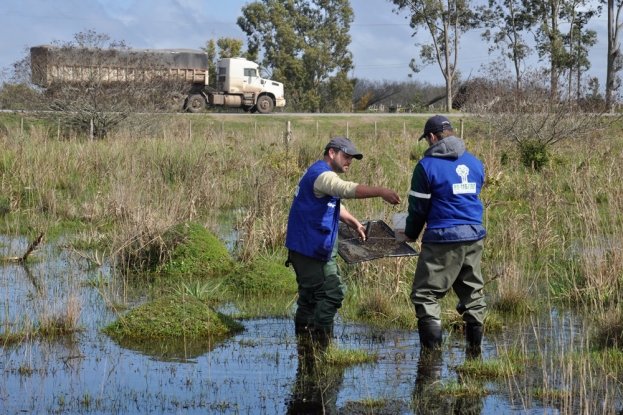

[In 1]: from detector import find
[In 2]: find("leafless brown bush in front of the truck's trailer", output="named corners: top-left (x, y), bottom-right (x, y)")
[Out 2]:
top-left (12, 30), bottom-right (186, 138)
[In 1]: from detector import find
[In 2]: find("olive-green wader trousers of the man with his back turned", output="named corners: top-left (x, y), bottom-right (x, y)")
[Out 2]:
top-left (411, 239), bottom-right (487, 324)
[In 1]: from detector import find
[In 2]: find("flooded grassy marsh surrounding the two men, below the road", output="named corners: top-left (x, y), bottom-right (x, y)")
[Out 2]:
top-left (0, 114), bottom-right (623, 414)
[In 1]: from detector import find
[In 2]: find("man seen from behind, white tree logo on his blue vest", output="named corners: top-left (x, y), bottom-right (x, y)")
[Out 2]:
top-left (405, 115), bottom-right (486, 354)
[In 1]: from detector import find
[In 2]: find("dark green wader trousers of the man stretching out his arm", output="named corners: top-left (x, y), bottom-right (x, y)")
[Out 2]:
top-left (288, 240), bottom-right (346, 331)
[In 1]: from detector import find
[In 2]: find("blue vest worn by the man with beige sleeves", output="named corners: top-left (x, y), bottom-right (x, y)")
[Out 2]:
top-left (286, 160), bottom-right (340, 262)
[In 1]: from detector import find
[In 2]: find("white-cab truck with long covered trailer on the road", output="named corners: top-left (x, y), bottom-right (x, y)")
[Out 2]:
top-left (30, 45), bottom-right (286, 114)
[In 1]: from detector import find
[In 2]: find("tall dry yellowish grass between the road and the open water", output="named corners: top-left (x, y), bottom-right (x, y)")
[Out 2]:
top-left (0, 116), bottom-right (623, 328)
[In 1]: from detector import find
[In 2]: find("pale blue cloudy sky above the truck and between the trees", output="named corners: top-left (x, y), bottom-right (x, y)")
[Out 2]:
top-left (0, 0), bottom-right (607, 89)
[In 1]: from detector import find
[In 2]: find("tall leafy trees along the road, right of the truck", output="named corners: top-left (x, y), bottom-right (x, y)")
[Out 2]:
top-left (230, 0), bottom-right (623, 111)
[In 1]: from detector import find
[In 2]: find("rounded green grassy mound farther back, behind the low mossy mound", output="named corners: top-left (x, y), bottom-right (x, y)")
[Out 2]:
top-left (158, 222), bottom-right (233, 277)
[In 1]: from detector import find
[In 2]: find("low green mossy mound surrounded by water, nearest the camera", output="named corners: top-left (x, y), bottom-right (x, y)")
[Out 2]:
top-left (104, 295), bottom-right (243, 338)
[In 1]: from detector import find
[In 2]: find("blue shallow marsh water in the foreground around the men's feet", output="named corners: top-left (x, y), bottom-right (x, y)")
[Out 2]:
top-left (0, 239), bottom-right (620, 414)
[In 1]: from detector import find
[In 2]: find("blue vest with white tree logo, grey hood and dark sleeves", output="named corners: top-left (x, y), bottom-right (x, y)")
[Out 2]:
top-left (405, 136), bottom-right (486, 243)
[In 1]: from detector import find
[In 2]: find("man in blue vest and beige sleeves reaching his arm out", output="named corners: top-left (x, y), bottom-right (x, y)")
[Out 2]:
top-left (286, 137), bottom-right (400, 339)
